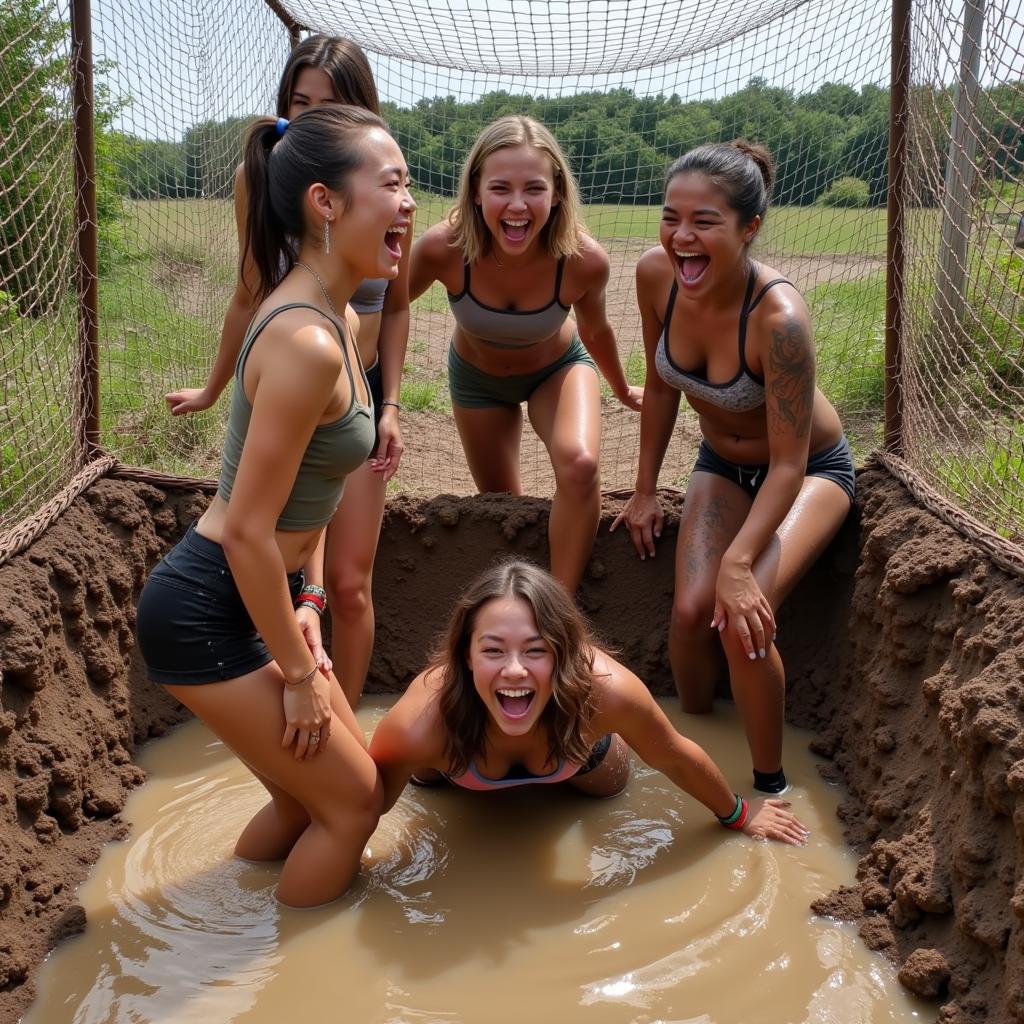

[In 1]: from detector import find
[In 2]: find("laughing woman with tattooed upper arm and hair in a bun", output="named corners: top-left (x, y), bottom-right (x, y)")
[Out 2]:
top-left (611, 140), bottom-right (853, 793)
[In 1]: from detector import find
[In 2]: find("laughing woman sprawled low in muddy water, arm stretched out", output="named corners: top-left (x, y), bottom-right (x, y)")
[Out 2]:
top-left (370, 561), bottom-right (807, 845)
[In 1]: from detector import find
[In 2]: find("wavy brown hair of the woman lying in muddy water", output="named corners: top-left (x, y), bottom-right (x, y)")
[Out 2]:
top-left (430, 559), bottom-right (597, 775)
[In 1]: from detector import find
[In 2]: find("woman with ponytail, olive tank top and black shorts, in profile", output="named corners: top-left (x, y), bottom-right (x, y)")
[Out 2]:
top-left (137, 105), bottom-right (415, 906)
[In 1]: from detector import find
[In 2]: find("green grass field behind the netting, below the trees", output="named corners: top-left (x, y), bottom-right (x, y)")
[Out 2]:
top-left (6, 196), bottom-right (1022, 528)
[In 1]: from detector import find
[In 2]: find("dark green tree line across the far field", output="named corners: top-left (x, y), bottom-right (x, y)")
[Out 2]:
top-left (115, 78), bottom-right (1024, 206)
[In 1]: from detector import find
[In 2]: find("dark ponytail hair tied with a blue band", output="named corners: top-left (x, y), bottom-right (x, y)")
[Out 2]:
top-left (242, 104), bottom-right (387, 302)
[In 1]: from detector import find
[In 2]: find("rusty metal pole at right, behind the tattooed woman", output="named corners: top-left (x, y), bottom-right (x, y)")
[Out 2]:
top-left (885, 0), bottom-right (912, 455)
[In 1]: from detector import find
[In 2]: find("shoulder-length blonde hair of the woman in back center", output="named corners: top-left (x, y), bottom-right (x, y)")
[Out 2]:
top-left (449, 114), bottom-right (585, 264)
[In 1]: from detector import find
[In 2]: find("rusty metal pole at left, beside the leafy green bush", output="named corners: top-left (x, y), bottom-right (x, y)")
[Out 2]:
top-left (71, 0), bottom-right (99, 465)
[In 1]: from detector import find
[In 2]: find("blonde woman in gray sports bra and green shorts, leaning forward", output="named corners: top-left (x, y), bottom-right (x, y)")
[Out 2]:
top-left (410, 116), bottom-right (642, 593)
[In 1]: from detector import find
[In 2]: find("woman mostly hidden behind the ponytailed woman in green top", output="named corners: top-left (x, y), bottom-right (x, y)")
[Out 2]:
top-left (159, 36), bottom-right (412, 706)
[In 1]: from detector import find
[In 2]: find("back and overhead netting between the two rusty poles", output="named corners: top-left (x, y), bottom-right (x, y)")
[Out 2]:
top-left (79, 0), bottom-right (889, 496)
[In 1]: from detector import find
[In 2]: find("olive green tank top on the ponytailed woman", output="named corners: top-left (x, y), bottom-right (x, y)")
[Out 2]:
top-left (217, 302), bottom-right (376, 530)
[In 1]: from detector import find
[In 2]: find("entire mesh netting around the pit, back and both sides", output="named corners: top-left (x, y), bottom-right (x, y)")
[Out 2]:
top-left (0, 0), bottom-right (1024, 561)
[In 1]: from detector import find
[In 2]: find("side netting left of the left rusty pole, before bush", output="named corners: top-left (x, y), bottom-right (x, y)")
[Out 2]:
top-left (0, 0), bottom-right (81, 531)
